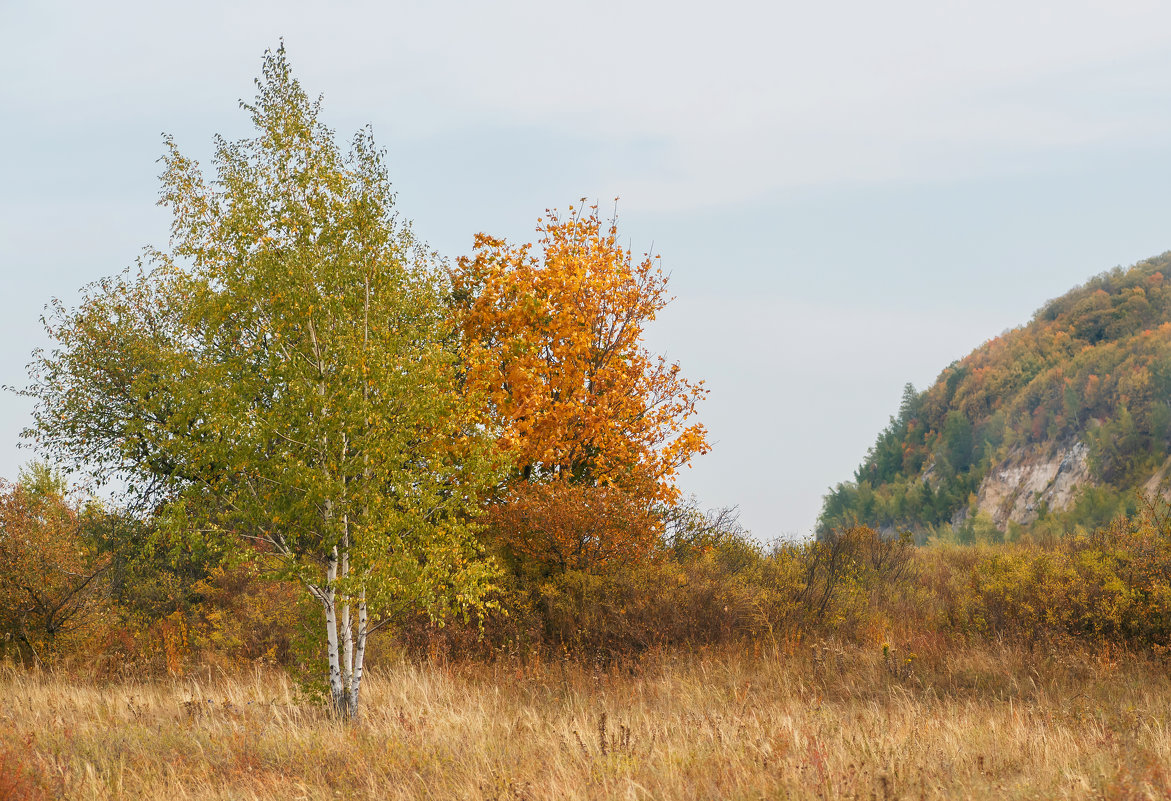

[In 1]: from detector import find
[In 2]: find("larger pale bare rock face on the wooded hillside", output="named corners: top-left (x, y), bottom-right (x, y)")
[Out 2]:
top-left (977, 441), bottom-right (1094, 530)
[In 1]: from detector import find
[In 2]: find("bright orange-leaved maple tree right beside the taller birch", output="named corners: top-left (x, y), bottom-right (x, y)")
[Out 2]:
top-left (452, 205), bottom-right (708, 504)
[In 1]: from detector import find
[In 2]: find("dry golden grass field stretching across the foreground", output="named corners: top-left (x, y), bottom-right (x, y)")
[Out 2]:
top-left (0, 642), bottom-right (1171, 800)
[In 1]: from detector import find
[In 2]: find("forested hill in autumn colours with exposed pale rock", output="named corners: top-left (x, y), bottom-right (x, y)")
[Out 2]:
top-left (819, 252), bottom-right (1171, 540)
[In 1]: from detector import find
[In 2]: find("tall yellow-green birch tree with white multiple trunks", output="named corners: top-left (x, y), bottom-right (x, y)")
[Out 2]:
top-left (20, 47), bottom-right (498, 716)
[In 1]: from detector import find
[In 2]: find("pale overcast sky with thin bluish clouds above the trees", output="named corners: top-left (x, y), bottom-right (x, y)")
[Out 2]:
top-left (0, 0), bottom-right (1171, 540)
